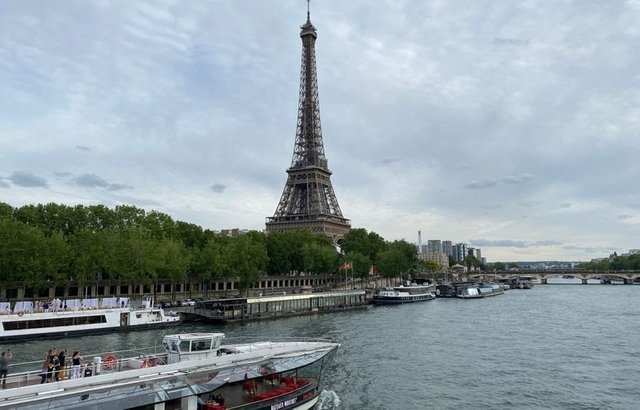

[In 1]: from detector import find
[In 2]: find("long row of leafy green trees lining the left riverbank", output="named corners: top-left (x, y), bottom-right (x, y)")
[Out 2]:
top-left (0, 203), bottom-right (429, 289)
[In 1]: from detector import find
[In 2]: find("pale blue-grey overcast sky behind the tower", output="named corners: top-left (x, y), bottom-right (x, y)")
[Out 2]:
top-left (0, 0), bottom-right (640, 261)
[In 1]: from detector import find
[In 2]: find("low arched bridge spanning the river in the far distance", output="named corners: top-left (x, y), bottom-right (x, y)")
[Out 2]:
top-left (488, 269), bottom-right (640, 285)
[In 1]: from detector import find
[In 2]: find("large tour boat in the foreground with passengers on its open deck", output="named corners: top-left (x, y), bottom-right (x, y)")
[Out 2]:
top-left (0, 333), bottom-right (340, 410)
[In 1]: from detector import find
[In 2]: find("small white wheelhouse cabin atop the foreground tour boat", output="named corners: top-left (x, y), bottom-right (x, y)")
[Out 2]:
top-left (162, 333), bottom-right (224, 364)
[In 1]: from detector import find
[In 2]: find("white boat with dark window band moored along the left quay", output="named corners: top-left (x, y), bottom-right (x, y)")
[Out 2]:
top-left (0, 297), bottom-right (180, 341)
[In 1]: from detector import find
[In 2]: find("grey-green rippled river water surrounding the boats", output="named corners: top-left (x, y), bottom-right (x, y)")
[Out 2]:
top-left (0, 285), bottom-right (640, 410)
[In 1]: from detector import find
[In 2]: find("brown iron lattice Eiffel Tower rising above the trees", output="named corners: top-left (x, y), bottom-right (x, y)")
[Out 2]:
top-left (266, 2), bottom-right (351, 243)
